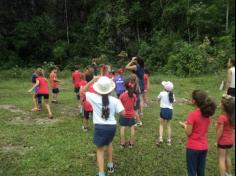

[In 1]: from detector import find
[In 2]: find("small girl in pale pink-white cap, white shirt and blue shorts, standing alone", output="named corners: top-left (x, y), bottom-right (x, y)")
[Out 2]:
top-left (157, 81), bottom-right (175, 146)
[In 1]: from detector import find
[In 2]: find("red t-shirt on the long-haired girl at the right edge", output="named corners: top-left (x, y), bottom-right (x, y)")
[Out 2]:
top-left (217, 115), bottom-right (234, 145)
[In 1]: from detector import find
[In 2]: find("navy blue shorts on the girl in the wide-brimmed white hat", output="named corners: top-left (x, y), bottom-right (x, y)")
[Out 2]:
top-left (93, 124), bottom-right (116, 147)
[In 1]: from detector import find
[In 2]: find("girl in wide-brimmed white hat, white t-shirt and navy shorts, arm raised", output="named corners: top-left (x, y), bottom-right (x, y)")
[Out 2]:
top-left (82, 77), bottom-right (124, 176)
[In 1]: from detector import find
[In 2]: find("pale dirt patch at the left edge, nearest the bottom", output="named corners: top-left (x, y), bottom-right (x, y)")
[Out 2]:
top-left (0, 144), bottom-right (33, 155)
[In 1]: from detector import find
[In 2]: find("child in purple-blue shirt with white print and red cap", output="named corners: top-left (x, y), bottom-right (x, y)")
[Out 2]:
top-left (114, 69), bottom-right (125, 98)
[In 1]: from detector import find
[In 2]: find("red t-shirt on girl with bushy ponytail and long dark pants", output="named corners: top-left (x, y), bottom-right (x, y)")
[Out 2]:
top-left (186, 109), bottom-right (211, 150)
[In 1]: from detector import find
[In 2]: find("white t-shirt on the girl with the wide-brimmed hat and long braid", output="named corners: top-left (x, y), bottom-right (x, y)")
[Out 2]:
top-left (85, 92), bottom-right (124, 125)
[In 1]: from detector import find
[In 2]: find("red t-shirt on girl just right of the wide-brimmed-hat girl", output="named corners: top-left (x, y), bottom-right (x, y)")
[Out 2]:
top-left (120, 92), bottom-right (137, 118)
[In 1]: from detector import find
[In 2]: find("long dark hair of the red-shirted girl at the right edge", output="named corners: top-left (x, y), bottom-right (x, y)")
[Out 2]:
top-left (221, 96), bottom-right (235, 127)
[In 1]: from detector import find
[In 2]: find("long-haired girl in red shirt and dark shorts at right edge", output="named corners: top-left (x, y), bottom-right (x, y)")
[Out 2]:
top-left (216, 95), bottom-right (235, 176)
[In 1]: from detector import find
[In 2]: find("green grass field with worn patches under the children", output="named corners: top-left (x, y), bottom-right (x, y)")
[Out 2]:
top-left (0, 74), bottom-right (235, 176)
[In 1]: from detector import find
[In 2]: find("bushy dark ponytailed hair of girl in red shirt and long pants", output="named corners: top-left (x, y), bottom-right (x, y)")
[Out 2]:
top-left (192, 90), bottom-right (217, 118)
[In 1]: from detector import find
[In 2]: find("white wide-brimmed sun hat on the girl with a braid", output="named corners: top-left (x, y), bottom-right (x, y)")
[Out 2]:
top-left (93, 76), bottom-right (116, 95)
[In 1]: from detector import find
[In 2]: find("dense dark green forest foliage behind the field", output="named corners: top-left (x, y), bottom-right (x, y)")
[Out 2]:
top-left (0, 0), bottom-right (235, 75)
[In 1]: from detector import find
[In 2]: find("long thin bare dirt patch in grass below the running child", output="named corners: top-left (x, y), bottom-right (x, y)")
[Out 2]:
top-left (9, 117), bottom-right (61, 125)
